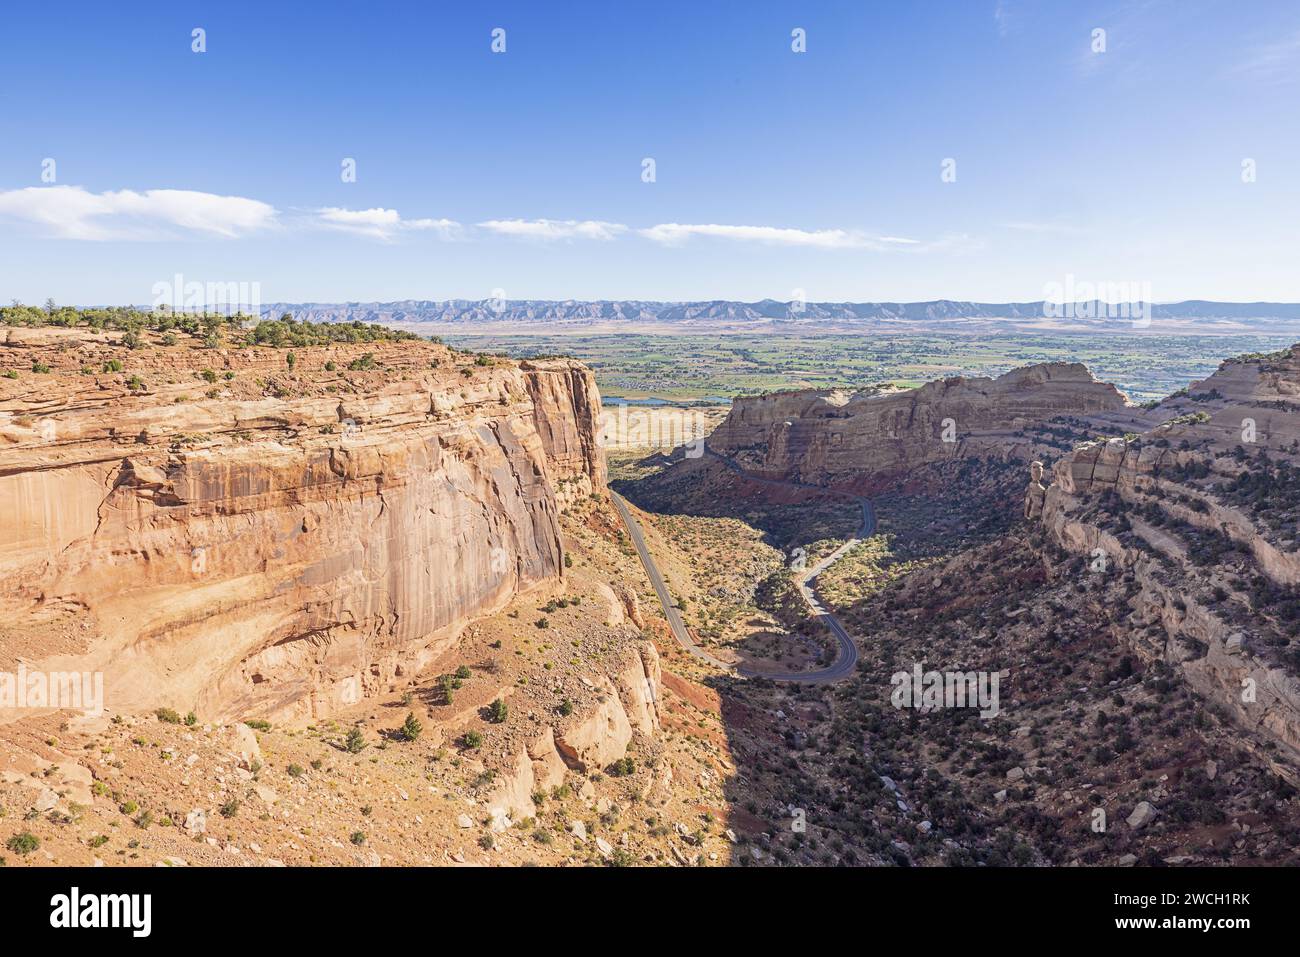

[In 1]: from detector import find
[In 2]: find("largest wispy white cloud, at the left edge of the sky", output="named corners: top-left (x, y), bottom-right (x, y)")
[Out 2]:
top-left (0, 186), bottom-right (277, 242)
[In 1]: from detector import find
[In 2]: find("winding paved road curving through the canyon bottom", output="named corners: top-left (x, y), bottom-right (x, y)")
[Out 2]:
top-left (610, 447), bottom-right (876, 684)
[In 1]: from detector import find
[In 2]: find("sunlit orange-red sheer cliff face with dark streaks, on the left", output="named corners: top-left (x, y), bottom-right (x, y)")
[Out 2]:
top-left (0, 330), bottom-right (605, 718)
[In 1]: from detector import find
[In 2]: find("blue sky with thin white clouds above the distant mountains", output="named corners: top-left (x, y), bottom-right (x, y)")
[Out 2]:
top-left (0, 0), bottom-right (1300, 303)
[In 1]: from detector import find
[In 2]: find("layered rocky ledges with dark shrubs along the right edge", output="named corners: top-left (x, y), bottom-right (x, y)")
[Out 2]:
top-left (1026, 346), bottom-right (1300, 781)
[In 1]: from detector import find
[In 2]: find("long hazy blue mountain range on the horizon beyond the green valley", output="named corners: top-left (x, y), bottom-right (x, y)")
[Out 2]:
top-left (253, 299), bottom-right (1300, 332)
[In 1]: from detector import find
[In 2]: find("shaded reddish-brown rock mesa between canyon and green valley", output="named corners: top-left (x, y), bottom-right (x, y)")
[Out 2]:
top-left (709, 363), bottom-right (1125, 493)
